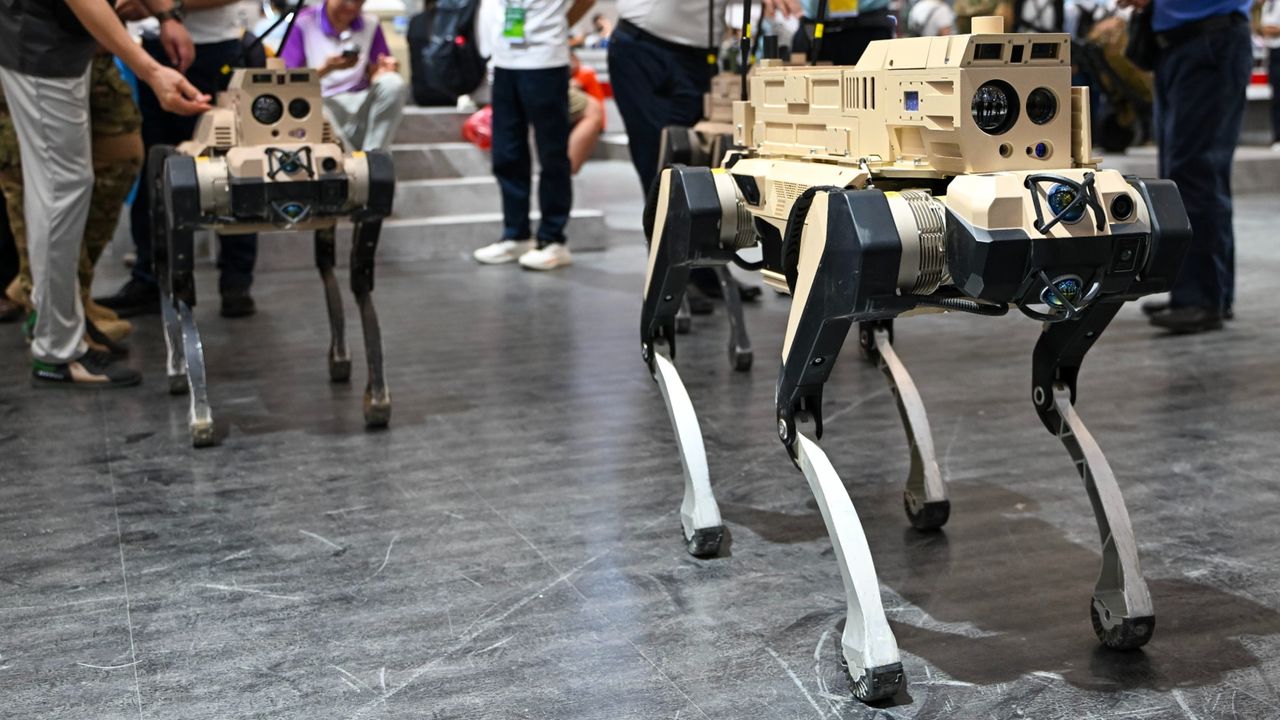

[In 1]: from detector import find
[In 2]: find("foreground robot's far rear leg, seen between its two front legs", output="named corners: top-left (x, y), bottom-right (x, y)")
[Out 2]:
top-left (858, 320), bottom-right (951, 530)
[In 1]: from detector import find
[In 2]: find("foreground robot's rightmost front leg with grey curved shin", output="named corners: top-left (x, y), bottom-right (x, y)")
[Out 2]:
top-left (1032, 302), bottom-right (1156, 650)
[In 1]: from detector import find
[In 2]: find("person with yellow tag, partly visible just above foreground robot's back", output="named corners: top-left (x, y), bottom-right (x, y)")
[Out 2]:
top-left (791, 0), bottom-right (893, 65)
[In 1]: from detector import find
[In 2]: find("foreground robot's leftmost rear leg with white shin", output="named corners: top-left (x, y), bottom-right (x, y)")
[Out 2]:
top-left (640, 165), bottom-right (754, 557)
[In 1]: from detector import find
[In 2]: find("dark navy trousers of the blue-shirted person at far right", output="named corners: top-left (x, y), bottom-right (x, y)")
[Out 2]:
top-left (1155, 22), bottom-right (1253, 311)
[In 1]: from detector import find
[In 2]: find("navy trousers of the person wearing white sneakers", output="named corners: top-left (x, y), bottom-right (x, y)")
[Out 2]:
top-left (493, 65), bottom-right (573, 247)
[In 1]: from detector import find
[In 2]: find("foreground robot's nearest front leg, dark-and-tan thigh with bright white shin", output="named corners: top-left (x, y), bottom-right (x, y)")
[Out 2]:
top-left (777, 191), bottom-right (905, 701)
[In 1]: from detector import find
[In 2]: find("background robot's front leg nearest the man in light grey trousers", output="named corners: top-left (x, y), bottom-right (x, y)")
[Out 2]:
top-left (159, 147), bottom-right (214, 447)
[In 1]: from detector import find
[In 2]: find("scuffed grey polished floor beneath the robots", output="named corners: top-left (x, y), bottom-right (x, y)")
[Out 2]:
top-left (0, 196), bottom-right (1280, 720)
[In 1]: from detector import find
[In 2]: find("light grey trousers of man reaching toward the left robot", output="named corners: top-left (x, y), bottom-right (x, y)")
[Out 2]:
top-left (0, 67), bottom-right (93, 364)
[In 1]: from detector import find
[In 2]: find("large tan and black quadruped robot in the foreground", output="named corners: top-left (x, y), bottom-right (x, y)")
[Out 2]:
top-left (640, 18), bottom-right (1190, 701)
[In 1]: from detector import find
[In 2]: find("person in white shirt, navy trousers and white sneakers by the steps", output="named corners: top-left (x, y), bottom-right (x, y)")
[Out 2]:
top-left (472, 0), bottom-right (595, 270)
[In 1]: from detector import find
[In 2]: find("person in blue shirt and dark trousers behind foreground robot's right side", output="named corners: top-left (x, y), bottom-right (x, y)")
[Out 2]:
top-left (1120, 0), bottom-right (1253, 333)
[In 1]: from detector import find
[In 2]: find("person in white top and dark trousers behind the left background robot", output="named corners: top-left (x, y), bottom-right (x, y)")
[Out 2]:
top-left (97, 0), bottom-right (257, 318)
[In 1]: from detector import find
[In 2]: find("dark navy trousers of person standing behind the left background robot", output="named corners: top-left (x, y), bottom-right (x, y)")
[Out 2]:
top-left (129, 38), bottom-right (257, 291)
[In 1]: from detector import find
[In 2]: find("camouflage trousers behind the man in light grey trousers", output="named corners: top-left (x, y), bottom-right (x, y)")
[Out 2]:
top-left (0, 55), bottom-right (142, 309)
